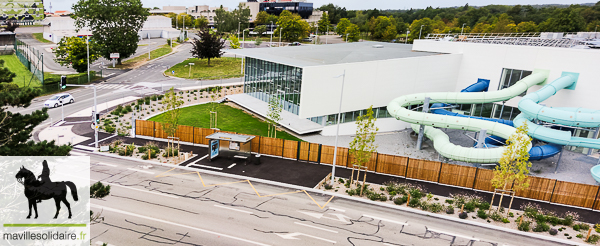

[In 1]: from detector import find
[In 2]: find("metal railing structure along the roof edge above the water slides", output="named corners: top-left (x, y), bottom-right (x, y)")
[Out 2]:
top-left (425, 32), bottom-right (586, 48)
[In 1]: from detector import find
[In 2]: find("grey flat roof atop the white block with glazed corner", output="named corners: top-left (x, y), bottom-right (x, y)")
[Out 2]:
top-left (227, 40), bottom-right (442, 67)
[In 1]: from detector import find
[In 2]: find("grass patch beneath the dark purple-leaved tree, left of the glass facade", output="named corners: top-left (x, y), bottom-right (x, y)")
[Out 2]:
top-left (165, 57), bottom-right (242, 79)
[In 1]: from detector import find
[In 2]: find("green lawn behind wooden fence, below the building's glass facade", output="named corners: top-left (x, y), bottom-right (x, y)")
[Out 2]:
top-left (150, 104), bottom-right (302, 141)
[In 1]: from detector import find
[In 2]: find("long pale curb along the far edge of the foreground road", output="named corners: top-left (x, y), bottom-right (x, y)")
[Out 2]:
top-left (86, 152), bottom-right (587, 245)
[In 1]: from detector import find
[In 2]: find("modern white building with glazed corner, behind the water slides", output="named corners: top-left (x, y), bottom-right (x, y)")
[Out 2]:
top-left (224, 33), bottom-right (600, 155)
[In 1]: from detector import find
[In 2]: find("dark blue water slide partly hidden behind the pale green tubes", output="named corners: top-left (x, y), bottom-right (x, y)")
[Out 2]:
top-left (431, 79), bottom-right (562, 161)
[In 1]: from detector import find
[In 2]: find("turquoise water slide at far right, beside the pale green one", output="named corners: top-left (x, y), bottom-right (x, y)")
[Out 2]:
top-left (514, 73), bottom-right (600, 182)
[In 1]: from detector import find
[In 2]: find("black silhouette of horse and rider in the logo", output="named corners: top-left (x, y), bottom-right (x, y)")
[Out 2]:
top-left (15, 160), bottom-right (79, 219)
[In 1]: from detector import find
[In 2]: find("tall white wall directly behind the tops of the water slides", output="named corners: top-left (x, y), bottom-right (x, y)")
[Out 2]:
top-left (413, 40), bottom-right (600, 109)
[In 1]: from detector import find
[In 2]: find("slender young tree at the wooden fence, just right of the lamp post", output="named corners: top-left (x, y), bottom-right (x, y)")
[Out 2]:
top-left (350, 105), bottom-right (379, 196)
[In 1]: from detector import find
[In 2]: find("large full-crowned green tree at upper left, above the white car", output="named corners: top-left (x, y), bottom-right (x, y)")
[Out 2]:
top-left (71, 0), bottom-right (150, 64)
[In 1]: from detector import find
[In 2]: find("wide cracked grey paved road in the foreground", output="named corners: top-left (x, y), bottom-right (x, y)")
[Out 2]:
top-left (81, 151), bottom-right (568, 246)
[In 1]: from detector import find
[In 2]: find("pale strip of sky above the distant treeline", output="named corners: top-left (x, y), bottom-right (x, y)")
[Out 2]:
top-left (49, 0), bottom-right (596, 11)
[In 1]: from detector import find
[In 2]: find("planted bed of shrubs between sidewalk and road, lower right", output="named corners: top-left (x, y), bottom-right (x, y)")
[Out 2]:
top-left (319, 178), bottom-right (600, 244)
